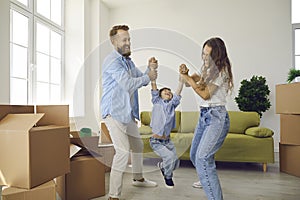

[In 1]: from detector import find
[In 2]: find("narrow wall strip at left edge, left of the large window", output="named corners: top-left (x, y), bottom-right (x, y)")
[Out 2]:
top-left (0, 0), bottom-right (10, 104)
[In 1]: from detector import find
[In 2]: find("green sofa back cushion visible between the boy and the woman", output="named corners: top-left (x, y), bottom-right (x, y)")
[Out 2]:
top-left (179, 111), bottom-right (199, 133)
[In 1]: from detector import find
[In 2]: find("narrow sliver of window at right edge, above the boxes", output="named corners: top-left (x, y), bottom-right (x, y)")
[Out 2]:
top-left (292, 0), bottom-right (300, 69)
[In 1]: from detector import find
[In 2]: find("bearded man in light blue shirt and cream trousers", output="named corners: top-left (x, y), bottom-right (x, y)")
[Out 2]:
top-left (101, 25), bottom-right (157, 200)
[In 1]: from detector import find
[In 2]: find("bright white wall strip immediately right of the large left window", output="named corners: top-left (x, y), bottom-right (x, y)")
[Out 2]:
top-left (64, 0), bottom-right (84, 116)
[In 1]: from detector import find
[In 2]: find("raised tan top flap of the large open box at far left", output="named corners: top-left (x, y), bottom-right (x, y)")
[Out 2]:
top-left (0, 113), bottom-right (44, 131)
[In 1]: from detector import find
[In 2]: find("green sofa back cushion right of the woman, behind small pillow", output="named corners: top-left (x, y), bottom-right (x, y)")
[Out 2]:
top-left (228, 111), bottom-right (260, 134)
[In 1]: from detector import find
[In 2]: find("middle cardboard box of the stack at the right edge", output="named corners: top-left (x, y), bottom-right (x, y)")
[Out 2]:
top-left (280, 114), bottom-right (300, 145)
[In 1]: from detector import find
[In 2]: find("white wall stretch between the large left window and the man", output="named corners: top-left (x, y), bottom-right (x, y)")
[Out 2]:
top-left (65, 0), bottom-right (108, 133)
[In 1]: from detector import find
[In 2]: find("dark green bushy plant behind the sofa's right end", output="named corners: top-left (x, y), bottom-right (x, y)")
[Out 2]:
top-left (234, 76), bottom-right (271, 117)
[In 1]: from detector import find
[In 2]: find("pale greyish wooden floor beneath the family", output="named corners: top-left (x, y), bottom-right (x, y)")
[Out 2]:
top-left (93, 155), bottom-right (300, 200)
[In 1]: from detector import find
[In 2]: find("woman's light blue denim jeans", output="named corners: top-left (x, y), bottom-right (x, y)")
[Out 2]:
top-left (190, 106), bottom-right (230, 200)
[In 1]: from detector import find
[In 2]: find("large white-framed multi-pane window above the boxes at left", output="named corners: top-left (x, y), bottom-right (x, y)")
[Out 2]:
top-left (10, 0), bottom-right (64, 104)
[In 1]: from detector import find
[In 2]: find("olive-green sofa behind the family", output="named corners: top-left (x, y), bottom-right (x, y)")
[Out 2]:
top-left (139, 111), bottom-right (274, 172)
